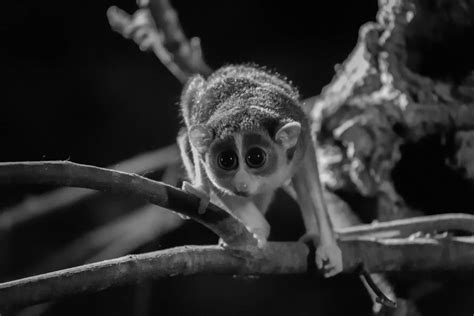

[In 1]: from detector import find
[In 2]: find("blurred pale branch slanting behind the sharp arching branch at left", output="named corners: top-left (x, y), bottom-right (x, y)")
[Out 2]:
top-left (0, 144), bottom-right (180, 232)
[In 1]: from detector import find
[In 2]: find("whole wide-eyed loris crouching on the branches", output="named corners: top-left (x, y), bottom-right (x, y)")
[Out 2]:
top-left (178, 66), bottom-right (342, 277)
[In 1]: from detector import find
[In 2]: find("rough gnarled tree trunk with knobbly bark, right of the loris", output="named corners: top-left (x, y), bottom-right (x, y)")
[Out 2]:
top-left (311, 0), bottom-right (474, 220)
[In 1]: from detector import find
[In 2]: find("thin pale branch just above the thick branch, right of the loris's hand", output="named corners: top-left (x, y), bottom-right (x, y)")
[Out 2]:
top-left (336, 213), bottom-right (474, 238)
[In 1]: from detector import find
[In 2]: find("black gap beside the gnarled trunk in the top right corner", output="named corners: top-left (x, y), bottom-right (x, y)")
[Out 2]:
top-left (405, 0), bottom-right (474, 84)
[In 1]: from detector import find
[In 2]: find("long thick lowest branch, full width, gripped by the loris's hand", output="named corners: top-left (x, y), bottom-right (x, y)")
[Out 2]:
top-left (0, 238), bottom-right (474, 308)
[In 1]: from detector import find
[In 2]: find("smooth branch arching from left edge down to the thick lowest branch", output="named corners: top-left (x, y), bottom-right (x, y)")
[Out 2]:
top-left (0, 161), bottom-right (257, 246)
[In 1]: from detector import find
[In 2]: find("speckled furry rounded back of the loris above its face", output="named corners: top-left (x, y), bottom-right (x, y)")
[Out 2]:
top-left (181, 65), bottom-right (308, 138)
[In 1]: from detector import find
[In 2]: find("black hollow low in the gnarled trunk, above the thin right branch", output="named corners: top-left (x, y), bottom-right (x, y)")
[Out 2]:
top-left (392, 135), bottom-right (474, 215)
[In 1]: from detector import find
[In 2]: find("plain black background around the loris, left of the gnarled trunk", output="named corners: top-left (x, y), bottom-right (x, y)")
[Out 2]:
top-left (0, 0), bottom-right (388, 315)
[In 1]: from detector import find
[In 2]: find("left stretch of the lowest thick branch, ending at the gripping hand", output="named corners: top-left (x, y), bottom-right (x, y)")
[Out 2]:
top-left (0, 243), bottom-right (308, 308)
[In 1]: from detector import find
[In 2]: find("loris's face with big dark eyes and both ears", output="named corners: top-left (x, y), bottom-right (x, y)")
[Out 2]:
top-left (189, 122), bottom-right (301, 196)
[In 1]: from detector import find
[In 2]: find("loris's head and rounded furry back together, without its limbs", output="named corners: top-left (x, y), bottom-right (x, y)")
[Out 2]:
top-left (181, 66), bottom-right (308, 196)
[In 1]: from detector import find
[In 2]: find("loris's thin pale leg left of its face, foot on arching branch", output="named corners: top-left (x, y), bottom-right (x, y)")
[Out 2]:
top-left (177, 132), bottom-right (210, 214)
